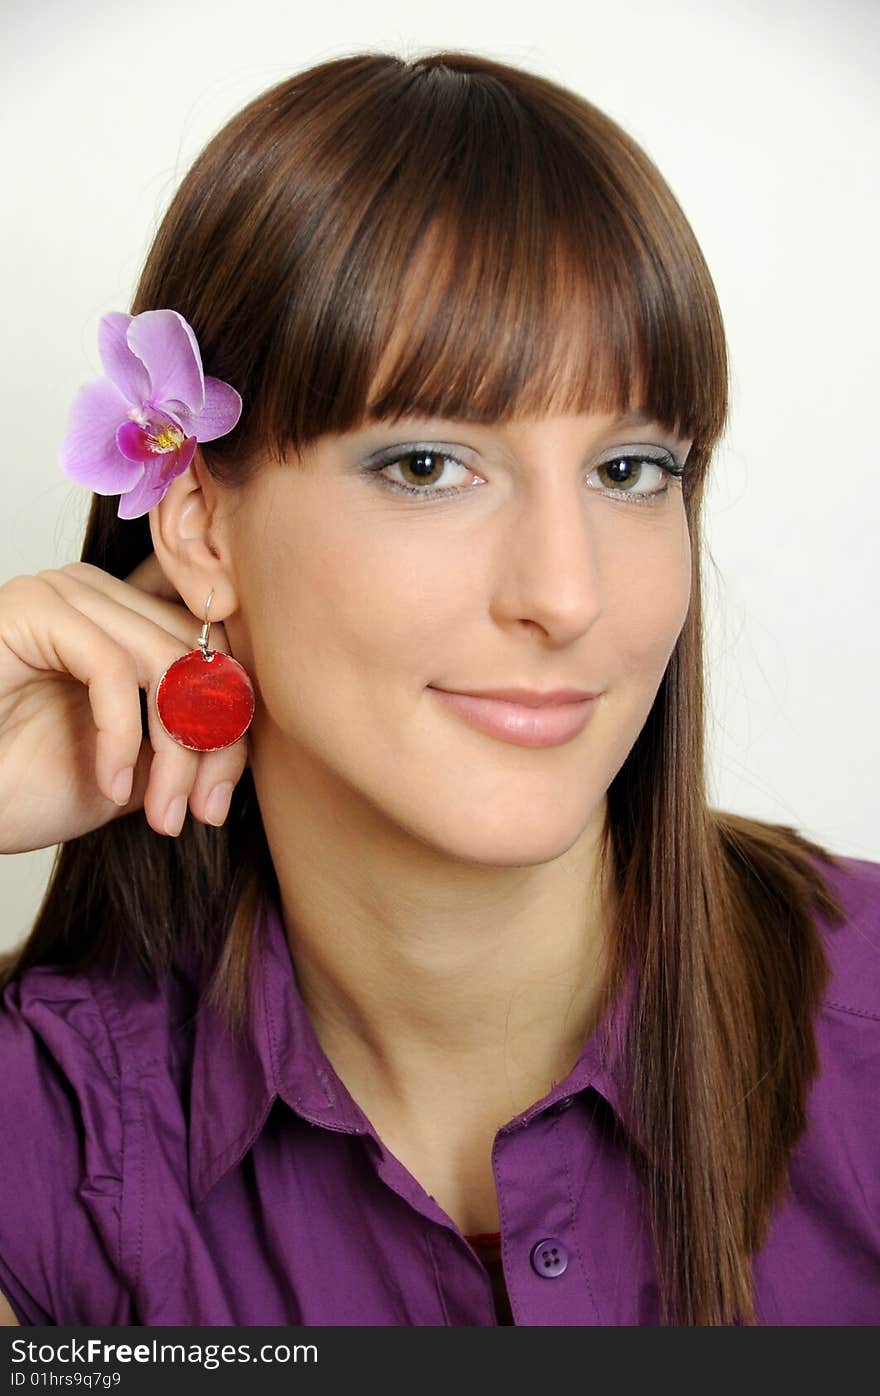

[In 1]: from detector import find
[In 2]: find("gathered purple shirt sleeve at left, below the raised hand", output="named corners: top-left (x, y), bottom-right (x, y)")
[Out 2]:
top-left (0, 949), bottom-right (194, 1325)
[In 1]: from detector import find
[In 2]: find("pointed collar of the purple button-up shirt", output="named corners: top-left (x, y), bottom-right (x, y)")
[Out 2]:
top-left (189, 893), bottom-right (636, 1208)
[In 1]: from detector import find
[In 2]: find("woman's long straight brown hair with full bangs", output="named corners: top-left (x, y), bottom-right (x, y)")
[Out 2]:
top-left (4, 52), bottom-right (844, 1325)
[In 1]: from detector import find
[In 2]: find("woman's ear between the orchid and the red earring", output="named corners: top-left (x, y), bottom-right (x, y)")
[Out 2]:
top-left (149, 450), bottom-right (239, 621)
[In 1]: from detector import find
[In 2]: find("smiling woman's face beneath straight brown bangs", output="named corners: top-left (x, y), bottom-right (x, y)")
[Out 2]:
top-left (215, 416), bottom-right (691, 866)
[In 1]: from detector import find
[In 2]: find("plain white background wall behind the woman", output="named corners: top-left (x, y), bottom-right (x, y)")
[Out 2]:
top-left (0, 0), bottom-right (880, 945)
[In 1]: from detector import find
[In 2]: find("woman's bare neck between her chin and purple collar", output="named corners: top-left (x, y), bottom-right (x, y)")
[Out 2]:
top-left (257, 753), bottom-right (612, 1129)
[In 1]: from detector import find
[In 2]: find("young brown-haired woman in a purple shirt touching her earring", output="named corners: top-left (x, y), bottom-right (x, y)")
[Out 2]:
top-left (0, 52), bottom-right (880, 1325)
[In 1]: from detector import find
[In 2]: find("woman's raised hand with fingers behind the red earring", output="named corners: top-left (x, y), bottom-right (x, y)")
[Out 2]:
top-left (0, 553), bottom-right (249, 853)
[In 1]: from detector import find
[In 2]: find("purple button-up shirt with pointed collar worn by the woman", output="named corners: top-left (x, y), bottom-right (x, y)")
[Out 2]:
top-left (0, 859), bottom-right (880, 1326)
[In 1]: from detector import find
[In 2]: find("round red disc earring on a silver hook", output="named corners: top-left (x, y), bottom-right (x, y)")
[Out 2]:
top-left (156, 592), bottom-right (256, 751)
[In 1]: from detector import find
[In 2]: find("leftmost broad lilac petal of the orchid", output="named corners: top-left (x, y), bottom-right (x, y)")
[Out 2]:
top-left (60, 378), bottom-right (142, 494)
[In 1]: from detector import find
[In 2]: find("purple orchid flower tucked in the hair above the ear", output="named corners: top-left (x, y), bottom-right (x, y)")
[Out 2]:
top-left (60, 310), bottom-right (242, 519)
